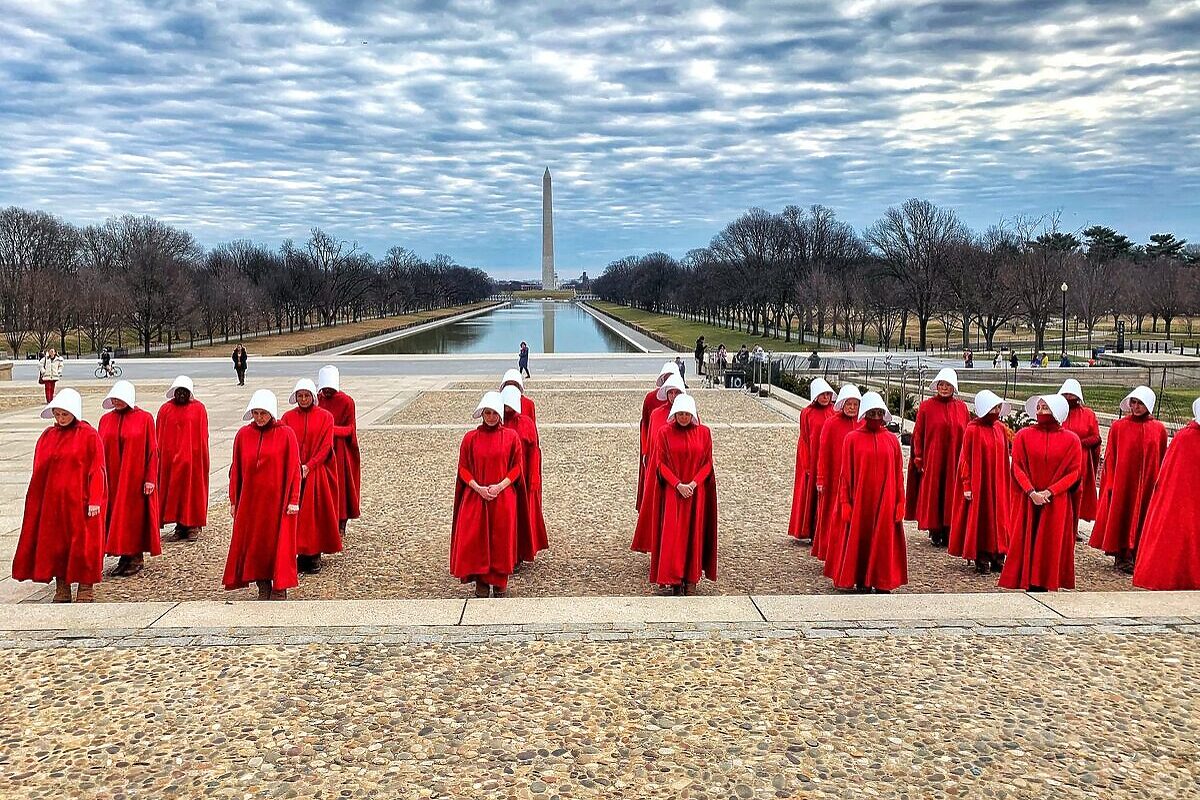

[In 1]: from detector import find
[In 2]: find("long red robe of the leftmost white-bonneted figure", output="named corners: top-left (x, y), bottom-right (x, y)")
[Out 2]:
top-left (12, 420), bottom-right (108, 583)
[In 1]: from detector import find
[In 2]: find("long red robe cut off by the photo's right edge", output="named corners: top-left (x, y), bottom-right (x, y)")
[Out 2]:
top-left (1133, 421), bottom-right (1200, 590)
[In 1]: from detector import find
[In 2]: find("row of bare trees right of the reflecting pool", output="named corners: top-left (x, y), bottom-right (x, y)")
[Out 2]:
top-left (593, 199), bottom-right (1200, 350)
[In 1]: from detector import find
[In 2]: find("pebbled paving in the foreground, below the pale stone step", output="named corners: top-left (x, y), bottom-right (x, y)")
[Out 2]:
top-left (0, 634), bottom-right (1200, 800)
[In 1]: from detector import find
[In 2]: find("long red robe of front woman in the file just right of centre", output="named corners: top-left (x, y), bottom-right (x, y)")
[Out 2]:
top-left (643, 422), bottom-right (716, 587)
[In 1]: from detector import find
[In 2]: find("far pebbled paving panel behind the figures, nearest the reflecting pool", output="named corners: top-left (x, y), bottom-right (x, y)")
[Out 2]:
top-left (388, 389), bottom-right (788, 425)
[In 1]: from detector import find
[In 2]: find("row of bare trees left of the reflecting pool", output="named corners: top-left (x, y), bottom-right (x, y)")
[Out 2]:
top-left (0, 206), bottom-right (493, 355)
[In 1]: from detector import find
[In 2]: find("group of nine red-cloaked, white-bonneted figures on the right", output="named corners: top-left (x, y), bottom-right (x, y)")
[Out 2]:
top-left (788, 369), bottom-right (1200, 593)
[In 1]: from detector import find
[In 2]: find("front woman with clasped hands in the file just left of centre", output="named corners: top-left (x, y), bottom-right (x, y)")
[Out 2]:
top-left (450, 392), bottom-right (523, 597)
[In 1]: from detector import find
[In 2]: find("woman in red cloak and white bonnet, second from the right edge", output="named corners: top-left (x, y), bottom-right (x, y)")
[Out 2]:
top-left (1088, 386), bottom-right (1166, 575)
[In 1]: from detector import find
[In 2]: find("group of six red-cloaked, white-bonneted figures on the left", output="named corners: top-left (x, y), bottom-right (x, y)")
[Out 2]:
top-left (12, 366), bottom-right (361, 603)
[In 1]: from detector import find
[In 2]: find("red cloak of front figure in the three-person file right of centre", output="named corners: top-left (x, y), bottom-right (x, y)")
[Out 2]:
top-left (826, 426), bottom-right (908, 591)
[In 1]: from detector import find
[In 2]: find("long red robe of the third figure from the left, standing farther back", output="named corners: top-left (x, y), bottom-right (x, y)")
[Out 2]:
top-left (154, 399), bottom-right (209, 528)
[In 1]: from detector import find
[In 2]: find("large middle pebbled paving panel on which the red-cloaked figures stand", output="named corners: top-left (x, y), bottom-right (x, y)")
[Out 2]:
top-left (96, 428), bottom-right (1132, 601)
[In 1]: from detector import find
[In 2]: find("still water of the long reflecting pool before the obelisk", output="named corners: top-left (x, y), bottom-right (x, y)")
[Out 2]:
top-left (358, 302), bottom-right (640, 355)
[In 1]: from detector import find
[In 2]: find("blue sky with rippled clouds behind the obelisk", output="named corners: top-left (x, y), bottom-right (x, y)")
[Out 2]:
top-left (0, 0), bottom-right (1200, 277)
